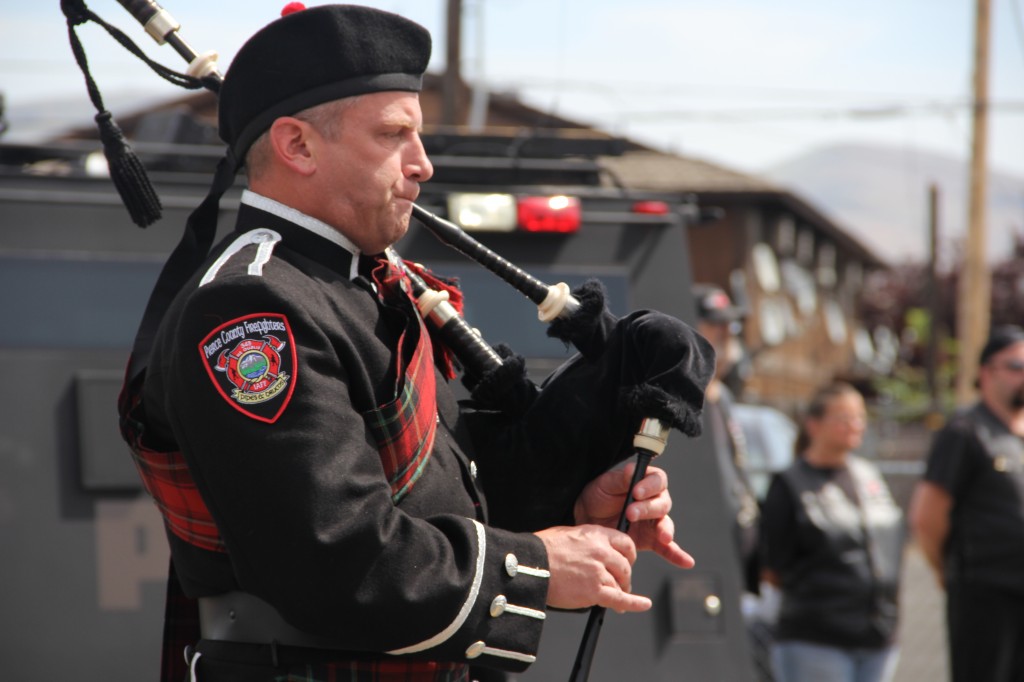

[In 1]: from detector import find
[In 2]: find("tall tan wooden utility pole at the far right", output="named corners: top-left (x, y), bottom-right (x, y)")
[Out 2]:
top-left (956, 0), bottom-right (992, 404)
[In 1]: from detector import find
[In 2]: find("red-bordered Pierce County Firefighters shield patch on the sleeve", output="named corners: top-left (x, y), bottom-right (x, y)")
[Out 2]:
top-left (199, 312), bottom-right (296, 424)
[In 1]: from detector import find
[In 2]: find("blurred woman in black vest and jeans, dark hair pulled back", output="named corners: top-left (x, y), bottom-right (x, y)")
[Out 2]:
top-left (761, 383), bottom-right (904, 682)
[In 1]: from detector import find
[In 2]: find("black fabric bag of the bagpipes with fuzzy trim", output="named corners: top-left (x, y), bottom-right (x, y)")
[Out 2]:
top-left (462, 280), bottom-right (715, 531)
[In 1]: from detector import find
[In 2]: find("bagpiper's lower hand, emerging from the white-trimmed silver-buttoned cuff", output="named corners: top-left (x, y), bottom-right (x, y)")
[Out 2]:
top-left (535, 524), bottom-right (651, 612)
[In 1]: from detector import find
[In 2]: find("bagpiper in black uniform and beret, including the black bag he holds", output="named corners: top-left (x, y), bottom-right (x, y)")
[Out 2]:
top-left (105, 5), bottom-right (714, 681)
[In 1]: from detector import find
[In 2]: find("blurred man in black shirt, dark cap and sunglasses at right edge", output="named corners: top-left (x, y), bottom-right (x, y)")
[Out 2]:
top-left (910, 326), bottom-right (1024, 682)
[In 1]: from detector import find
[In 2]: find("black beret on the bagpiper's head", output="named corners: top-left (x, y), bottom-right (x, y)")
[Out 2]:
top-left (218, 5), bottom-right (430, 159)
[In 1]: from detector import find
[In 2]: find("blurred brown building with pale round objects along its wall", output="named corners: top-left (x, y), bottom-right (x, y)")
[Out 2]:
top-left (607, 152), bottom-right (897, 414)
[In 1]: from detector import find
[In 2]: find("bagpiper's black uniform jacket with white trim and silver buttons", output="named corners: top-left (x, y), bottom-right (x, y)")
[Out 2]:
top-left (144, 193), bottom-right (552, 670)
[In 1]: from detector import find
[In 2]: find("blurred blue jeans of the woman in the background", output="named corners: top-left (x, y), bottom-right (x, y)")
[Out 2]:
top-left (771, 641), bottom-right (899, 682)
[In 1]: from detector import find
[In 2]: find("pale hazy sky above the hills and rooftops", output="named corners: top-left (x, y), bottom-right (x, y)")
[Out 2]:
top-left (0, 0), bottom-right (1024, 178)
